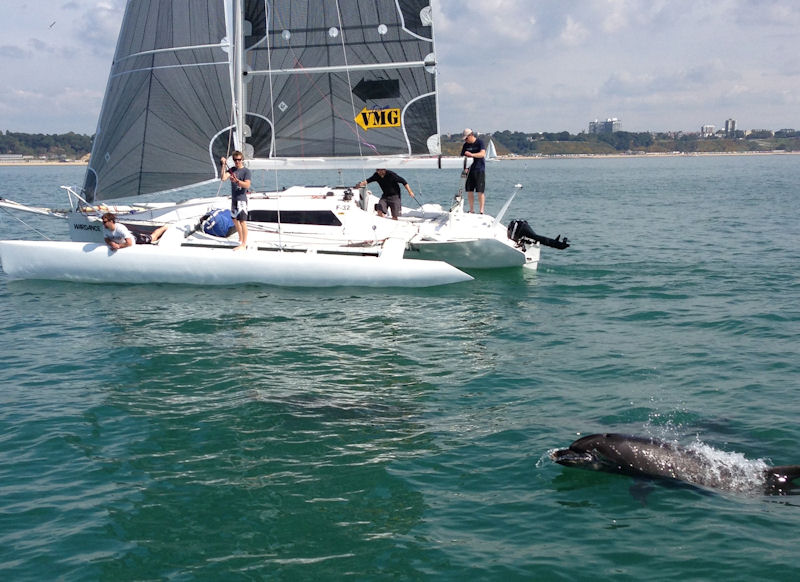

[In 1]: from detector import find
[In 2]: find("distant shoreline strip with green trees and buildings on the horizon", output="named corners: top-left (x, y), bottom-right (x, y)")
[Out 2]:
top-left (0, 130), bottom-right (800, 159)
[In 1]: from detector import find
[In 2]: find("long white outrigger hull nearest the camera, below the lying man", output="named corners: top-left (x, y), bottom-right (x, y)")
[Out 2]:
top-left (0, 241), bottom-right (472, 287)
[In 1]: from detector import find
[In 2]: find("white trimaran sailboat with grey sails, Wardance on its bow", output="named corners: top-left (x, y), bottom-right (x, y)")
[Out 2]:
top-left (0, 0), bottom-right (567, 287)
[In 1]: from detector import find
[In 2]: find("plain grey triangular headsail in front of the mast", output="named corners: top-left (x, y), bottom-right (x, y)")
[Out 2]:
top-left (84, 0), bottom-right (232, 202)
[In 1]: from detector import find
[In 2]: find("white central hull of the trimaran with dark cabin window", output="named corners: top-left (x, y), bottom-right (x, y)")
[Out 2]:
top-left (64, 186), bottom-right (540, 269)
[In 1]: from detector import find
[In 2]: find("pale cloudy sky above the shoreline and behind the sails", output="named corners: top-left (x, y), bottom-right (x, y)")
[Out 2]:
top-left (0, 0), bottom-right (800, 134)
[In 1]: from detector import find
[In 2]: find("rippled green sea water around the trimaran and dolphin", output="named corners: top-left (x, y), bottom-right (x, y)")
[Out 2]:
top-left (0, 155), bottom-right (800, 582)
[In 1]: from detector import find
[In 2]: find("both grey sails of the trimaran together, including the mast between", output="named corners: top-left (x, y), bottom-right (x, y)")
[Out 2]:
top-left (84, 0), bottom-right (440, 201)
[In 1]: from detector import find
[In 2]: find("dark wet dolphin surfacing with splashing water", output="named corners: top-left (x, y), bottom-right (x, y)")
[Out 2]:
top-left (550, 433), bottom-right (800, 495)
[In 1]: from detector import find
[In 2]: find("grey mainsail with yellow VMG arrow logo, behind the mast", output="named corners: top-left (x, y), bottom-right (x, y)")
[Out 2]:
top-left (246, 0), bottom-right (439, 158)
